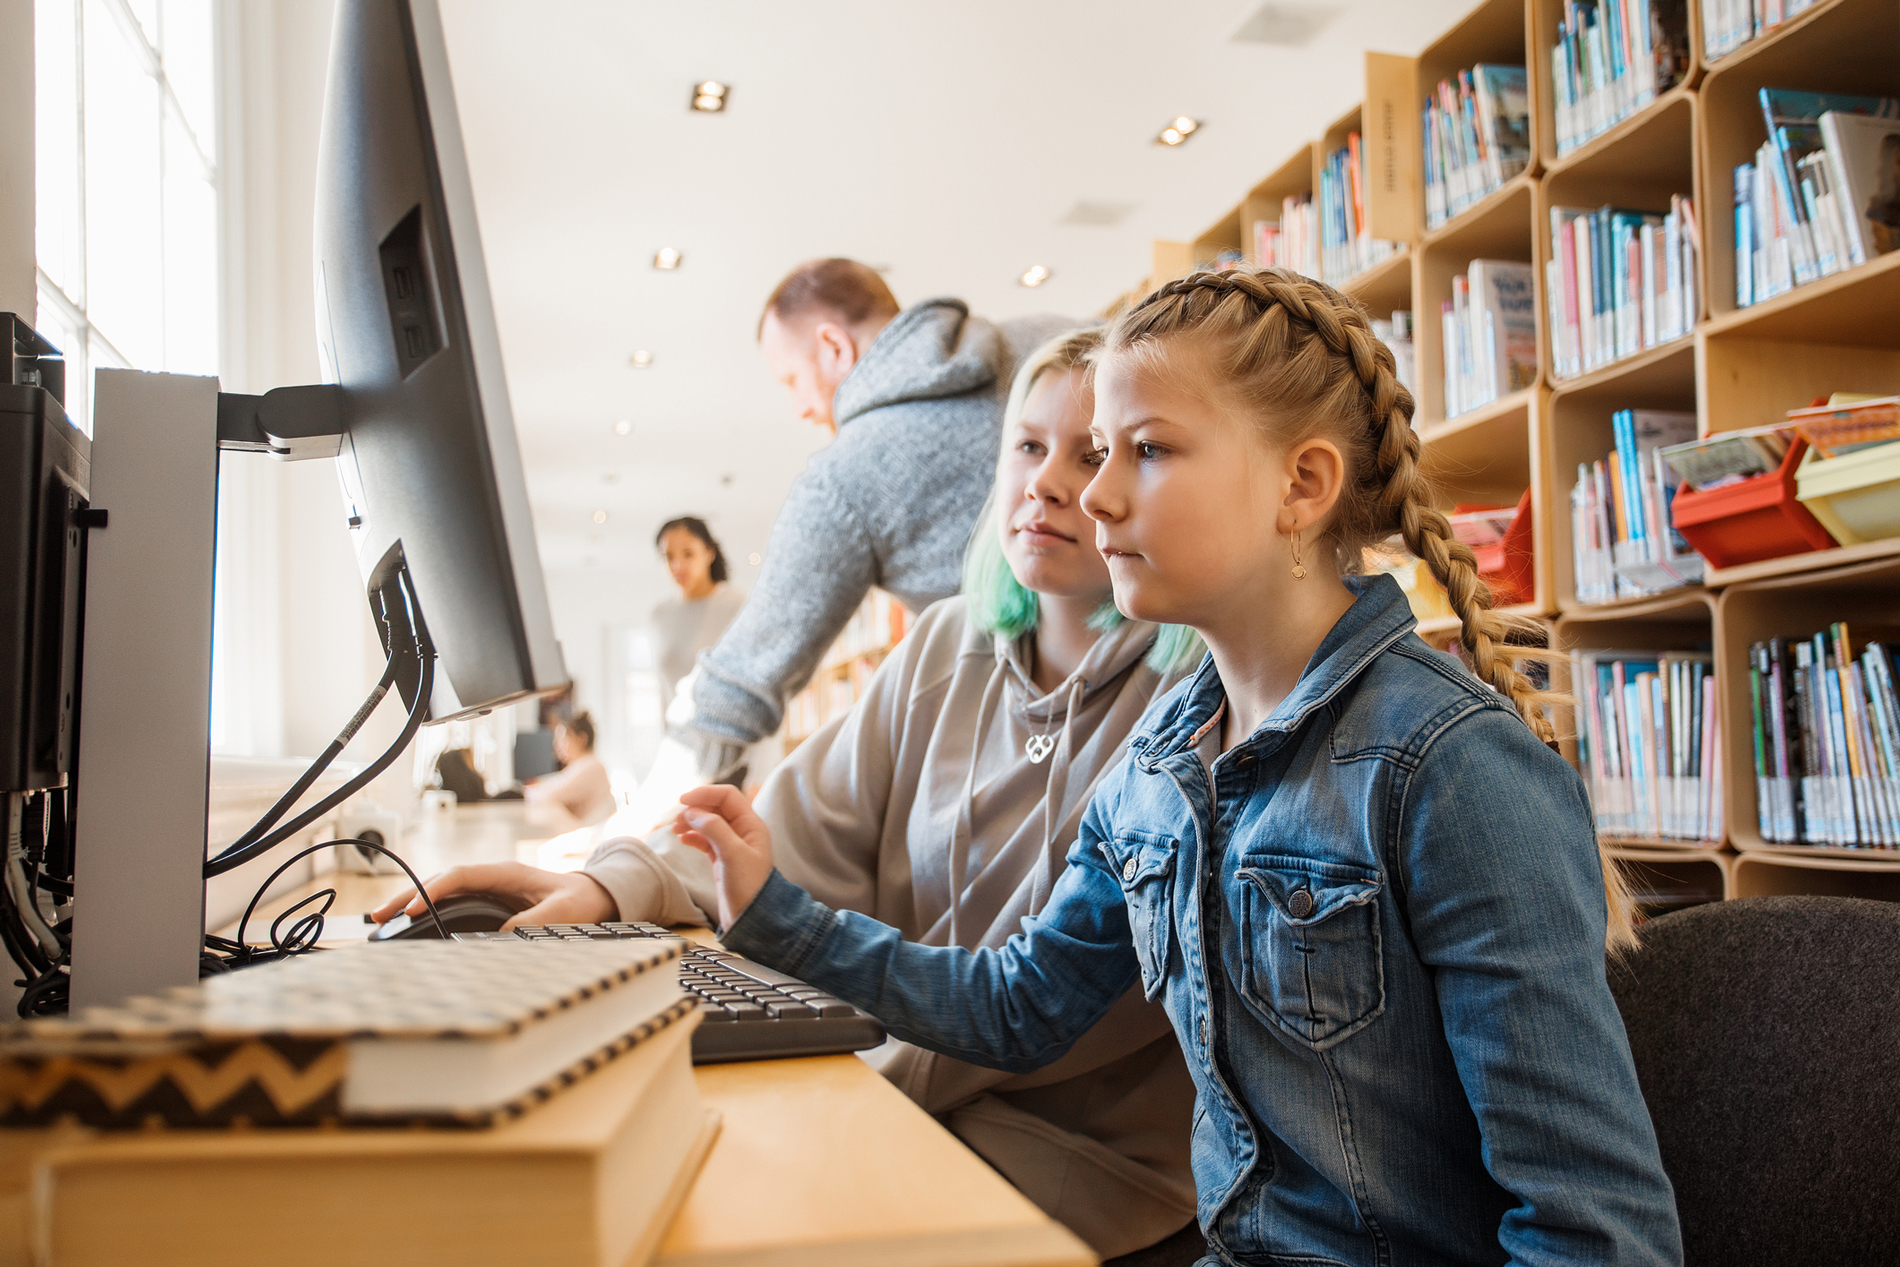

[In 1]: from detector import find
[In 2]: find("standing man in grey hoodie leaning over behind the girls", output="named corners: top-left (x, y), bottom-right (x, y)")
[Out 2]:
top-left (682, 260), bottom-right (1081, 779)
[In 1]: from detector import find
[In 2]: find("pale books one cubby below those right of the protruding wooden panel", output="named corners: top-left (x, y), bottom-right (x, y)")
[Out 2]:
top-left (1438, 260), bottom-right (1537, 418)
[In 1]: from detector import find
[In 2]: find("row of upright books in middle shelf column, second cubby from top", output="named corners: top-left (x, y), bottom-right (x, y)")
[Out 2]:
top-left (1545, 196), bottom-right (1701, 378)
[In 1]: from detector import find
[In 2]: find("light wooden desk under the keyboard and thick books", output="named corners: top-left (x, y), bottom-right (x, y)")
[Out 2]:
top-left (181, 807), bottom-right (1096, 1267)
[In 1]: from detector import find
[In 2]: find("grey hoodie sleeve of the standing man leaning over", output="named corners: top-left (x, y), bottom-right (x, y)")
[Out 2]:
top-left (694, 471), bottom-right (878, 752)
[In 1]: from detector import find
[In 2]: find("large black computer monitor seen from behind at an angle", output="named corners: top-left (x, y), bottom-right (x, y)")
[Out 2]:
top-left (315, 0), bottom-right (566, 722)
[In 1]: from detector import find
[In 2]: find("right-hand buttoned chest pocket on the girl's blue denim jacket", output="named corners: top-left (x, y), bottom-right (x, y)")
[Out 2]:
top-left (1229, 853), bottom-right (1385, 1050)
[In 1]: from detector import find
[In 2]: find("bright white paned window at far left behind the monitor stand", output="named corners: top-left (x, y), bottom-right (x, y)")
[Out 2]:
top-left (34, 0), bottom-right (219, 431)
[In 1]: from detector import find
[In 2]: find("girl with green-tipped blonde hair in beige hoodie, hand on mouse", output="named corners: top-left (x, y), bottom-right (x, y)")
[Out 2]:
top-left (376, 331), bottom-right (1199, 1265)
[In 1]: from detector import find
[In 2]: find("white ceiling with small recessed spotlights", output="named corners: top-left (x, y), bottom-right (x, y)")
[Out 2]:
top-left (443, 0), bottom-right (1469, 615)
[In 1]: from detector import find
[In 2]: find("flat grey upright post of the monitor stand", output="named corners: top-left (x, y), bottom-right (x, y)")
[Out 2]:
top-left (72, 370), bottom-right (219, 1009)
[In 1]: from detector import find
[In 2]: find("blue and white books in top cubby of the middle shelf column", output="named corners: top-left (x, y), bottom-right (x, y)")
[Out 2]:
top-left (1550, 0), bottom-right (1689, 156)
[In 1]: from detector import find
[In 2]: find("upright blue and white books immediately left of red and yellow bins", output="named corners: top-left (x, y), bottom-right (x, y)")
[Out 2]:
top-left (1569, 408), bottom-right (1704, 602)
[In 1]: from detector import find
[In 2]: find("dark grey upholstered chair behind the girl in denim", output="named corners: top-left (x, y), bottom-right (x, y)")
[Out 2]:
top-left (1609, 897), bottom-right (1900, 1267)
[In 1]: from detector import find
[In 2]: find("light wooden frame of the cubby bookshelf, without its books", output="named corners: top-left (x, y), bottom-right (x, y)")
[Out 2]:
top-left (1124, 0), bottom-right (1900, 904)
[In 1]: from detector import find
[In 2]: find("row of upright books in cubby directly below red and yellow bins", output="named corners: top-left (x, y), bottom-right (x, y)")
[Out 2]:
top-left (1748, 623), bottom-right (1900, 849)
